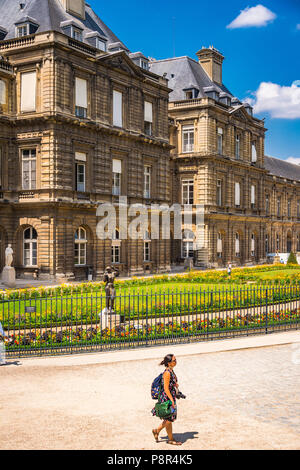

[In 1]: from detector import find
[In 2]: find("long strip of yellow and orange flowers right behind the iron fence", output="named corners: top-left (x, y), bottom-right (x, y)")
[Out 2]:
top-left (6, 309), bottom-right (300, 352)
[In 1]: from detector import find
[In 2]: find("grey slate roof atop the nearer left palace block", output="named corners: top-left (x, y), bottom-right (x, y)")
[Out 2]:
top-left (0, 0), bottom-right (126, 48)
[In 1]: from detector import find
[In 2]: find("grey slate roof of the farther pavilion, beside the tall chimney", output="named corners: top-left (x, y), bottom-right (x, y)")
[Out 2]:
top-left (150, 56), bottom-right (234, 101)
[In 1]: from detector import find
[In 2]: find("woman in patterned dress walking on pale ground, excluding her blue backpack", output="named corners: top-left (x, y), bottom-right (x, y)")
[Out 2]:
top-left (152, 354), bottom-right (182, 446)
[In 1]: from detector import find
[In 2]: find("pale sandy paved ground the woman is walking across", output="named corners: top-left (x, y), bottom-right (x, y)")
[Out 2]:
top-left (0, 332), bottom-right (300, 450)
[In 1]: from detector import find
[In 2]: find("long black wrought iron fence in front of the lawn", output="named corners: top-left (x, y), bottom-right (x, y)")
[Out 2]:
top-left (0, 285), bottom-right (300, 357)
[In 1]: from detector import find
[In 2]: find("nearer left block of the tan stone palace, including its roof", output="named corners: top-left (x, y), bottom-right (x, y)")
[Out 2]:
top-left (0, 0), bottom-right (171, 280)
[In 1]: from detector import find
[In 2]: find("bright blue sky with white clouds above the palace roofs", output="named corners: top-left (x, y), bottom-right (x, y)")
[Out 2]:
top-left (88, 0), bottom-right (300, 163)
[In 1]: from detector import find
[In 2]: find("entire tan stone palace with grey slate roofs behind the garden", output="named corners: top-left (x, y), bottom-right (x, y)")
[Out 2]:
top-left (0, 0), bottom-right (300, 280)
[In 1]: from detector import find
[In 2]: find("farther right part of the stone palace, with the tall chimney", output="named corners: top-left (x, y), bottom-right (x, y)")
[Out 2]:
top-left (150, 47), bottom-right (300, 267)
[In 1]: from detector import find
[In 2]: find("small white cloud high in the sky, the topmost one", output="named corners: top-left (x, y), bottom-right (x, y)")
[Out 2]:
top-left (227, 5), bottom-right (277, 29)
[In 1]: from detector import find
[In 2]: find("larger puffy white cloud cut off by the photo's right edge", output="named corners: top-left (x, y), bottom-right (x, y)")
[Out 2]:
top-left (247, 80), bottom-right (300, 119)
